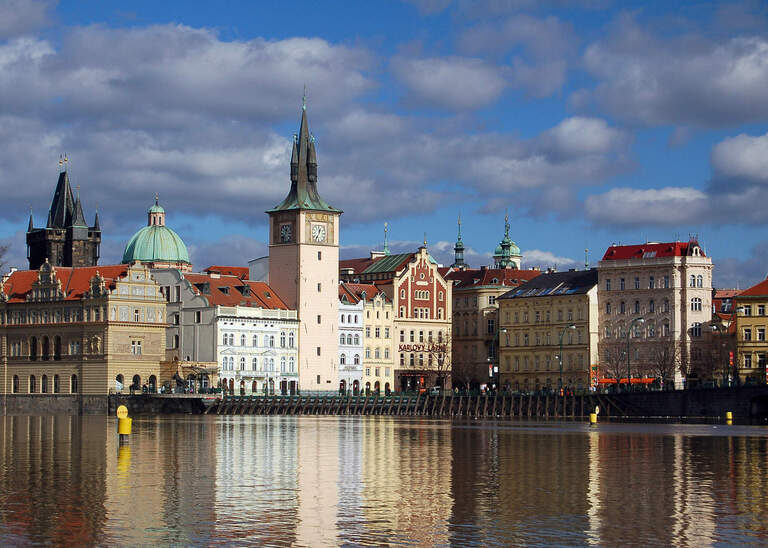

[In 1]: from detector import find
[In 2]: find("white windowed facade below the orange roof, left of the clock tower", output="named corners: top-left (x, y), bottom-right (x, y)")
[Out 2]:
top-left (215, 306), bottom-right (299, 395)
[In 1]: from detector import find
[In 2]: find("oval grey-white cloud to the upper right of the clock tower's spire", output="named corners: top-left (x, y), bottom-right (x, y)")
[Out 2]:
top-left (390, 57), bottom-right (506, 110)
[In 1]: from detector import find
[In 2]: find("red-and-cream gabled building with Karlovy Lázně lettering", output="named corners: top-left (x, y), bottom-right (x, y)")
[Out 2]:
top-left (339, 246), bottom-right (452, 391)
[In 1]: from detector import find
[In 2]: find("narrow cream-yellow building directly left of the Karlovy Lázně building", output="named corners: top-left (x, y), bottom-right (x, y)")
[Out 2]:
top-left (362, 293), bottom-right (395, 393)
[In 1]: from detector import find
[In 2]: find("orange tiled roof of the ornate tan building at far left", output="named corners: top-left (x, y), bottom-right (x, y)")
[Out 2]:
top-left (3, 264), bottom-right (128, 303)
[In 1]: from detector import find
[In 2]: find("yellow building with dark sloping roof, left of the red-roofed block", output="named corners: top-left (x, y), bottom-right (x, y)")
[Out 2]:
top-left (498, 269), bottom-right (598, 391)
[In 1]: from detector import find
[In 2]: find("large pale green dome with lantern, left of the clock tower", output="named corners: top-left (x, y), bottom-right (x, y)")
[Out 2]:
top-left (122, 197), bottom-right (192, 271)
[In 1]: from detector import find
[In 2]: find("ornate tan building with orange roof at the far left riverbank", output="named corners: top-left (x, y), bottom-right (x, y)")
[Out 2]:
top-left (0, 263), bottom-right (166, 395)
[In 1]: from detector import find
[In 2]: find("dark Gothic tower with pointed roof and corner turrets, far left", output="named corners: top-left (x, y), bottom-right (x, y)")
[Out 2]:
top-left (27, 158), bottom-right (101, 270)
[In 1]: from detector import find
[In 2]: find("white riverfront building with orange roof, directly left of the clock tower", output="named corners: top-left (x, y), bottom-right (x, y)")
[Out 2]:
top-left (152, 267), bottom-right (298, 394)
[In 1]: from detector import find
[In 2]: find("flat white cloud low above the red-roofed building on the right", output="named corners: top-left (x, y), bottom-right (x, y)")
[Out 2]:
top-left (585, 187), bottom-right (709, 226)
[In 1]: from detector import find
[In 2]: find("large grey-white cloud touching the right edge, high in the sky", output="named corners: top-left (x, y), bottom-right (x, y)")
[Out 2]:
top-left (579, 16), bottom-right (768, 127)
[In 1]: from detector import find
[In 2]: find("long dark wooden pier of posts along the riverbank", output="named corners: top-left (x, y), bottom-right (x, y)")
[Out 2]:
top-left (205, 393), bottom-right (632, 419)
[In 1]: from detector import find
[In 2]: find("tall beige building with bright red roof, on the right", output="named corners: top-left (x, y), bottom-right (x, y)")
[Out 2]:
top-left (598, 240), bottom-right (712, 387)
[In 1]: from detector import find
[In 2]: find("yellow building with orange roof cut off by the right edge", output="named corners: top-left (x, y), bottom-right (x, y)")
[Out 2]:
top-left (733, 279), bottom-right (768, 383)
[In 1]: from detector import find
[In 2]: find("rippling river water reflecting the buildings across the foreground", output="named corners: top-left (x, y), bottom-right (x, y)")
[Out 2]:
top-left (0, 416), bottom-right (768, 546)
